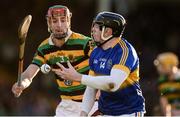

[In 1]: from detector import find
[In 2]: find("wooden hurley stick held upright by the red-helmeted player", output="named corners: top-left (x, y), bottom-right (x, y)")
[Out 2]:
top-left (15, 15), bottom-right (32, 97)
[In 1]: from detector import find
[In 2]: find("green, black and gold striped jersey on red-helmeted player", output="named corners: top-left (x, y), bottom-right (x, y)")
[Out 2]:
top-left (32, 32), bottom-right (92, 100)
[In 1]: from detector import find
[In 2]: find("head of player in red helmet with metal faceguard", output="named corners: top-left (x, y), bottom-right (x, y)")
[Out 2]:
top-left (47, 5), bottom-right (71, 39)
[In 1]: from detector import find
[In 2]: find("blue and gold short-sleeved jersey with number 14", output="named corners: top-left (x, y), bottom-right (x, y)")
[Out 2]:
top-left (89, 38), bottom-right (145, 115)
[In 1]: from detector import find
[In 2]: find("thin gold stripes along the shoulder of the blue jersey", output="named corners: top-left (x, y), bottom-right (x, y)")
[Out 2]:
top-left (119, 41), bottom-right (129, 65)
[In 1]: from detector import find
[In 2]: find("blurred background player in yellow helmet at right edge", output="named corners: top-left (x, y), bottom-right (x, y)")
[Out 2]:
top-left (154, 52), bottom-right (180, 116)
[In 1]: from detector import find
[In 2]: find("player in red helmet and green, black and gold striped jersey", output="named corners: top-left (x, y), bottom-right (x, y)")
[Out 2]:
top-left (12, 5), bottom-right (97, 116)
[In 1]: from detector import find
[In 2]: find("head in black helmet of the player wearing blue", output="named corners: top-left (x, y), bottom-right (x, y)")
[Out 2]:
top-left (91, 12), bottom-right (126, 46)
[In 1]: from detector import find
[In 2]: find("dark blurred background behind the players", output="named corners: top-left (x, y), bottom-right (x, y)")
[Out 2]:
top-left (0, 0), bottom-right (180, 116)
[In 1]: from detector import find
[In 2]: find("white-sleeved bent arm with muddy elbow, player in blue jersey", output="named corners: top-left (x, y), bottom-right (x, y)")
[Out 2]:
top-left (81, 69), bottom-right (129, 92)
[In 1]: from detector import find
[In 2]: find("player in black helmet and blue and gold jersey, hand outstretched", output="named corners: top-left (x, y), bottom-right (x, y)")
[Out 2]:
top-left (53, 12), bottom-right (145, 116)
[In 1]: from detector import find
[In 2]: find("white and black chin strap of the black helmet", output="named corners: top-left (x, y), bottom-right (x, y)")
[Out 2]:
top-left (95, 26), bottom-right (113, 47)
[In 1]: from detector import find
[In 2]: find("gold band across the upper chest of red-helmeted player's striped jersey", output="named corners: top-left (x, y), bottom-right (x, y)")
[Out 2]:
top-left (45, 50), bottom-right (84, 60)
